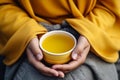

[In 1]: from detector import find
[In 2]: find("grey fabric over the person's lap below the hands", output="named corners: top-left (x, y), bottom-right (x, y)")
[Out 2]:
top-left (5, 53), bottom-right (118, 80)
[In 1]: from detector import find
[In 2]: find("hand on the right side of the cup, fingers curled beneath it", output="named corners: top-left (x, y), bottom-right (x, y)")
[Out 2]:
top-left (52, 36), bottom-right (90, 73)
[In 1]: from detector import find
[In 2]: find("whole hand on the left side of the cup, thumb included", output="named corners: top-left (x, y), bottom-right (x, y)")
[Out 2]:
top-left (26, 38), bottom-right (64, 77)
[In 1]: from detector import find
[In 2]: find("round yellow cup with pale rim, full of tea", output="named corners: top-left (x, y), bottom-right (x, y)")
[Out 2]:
top-left (39, 30), bottom-right (76, 64)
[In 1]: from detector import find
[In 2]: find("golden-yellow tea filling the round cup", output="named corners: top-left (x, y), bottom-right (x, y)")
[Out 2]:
top-left (42, 34), bottom-right (75, 54)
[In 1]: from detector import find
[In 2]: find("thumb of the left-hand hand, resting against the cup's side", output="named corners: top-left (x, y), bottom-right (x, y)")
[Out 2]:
top-left (29, 38), bottom-right (43, 60)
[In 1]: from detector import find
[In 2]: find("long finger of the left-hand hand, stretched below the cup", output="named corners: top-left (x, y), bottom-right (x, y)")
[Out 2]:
top-left (27, 49), bottom-right (58, 77)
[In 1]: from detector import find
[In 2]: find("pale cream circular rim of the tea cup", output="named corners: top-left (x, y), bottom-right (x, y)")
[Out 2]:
top-left (39, 30), bottom-right (77, 56)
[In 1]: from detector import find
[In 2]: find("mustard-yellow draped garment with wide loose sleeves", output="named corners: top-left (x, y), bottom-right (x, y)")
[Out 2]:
top-left (0, 0), bottom-right (120, 65)
